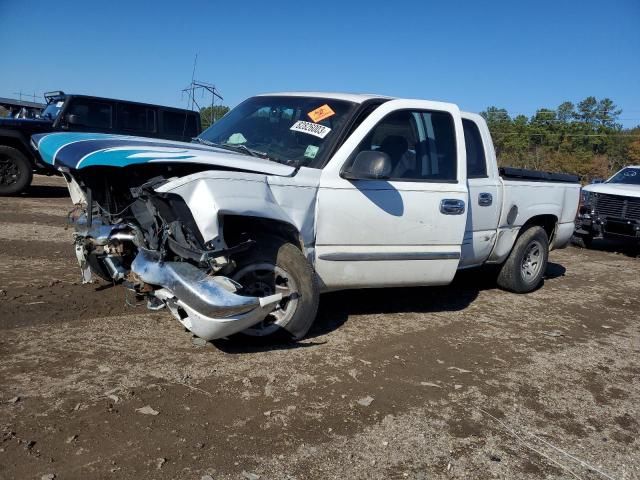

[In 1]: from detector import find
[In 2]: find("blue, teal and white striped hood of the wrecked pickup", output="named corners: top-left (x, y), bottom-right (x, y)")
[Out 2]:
top-left (31, 133), bottom-right (295, 176)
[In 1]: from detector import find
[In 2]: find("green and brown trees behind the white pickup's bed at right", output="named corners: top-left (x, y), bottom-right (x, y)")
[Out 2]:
top-left (481, 97), bottom-right (640, 182)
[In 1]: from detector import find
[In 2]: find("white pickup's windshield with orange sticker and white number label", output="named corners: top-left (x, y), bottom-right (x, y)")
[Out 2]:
top-left (199, 96), bottom-right (355, 168)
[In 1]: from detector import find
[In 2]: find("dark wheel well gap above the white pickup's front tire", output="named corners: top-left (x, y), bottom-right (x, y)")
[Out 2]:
top-left (220, 215), bottom-right (302, 250)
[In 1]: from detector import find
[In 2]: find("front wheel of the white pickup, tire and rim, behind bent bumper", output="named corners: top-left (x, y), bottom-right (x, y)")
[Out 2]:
top-left (231, 236), bottom-right (319, 344)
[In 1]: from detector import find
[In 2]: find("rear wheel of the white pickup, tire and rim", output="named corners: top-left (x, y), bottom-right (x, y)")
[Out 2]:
top-left (497, 226), bottom-right (549, 293)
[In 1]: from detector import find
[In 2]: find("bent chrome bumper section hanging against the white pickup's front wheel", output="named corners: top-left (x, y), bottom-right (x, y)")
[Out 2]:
top-left (131, 248), bottom-right (282, 340)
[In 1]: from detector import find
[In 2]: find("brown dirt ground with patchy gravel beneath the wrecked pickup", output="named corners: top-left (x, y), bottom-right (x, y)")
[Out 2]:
top-left (0, 178), bottom-right (640, 480)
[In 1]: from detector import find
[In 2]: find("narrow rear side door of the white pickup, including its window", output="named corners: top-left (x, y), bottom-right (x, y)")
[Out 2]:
top-left (460, 112), bottom-right (502, 268)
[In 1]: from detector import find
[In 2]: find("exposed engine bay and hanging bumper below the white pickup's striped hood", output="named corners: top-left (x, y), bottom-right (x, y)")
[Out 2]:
top-left (65, 165), bottom-right (282, 339)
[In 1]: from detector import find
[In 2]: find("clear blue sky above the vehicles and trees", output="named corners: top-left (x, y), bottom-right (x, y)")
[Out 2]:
top-left (0, 0), bottom-right (640, 126)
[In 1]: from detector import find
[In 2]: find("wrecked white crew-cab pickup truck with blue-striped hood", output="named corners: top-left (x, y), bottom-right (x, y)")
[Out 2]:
top-left (32, 92), bottom-right (580, 340)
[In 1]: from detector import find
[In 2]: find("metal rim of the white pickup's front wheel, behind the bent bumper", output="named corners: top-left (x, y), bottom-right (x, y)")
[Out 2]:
top-left (232, 262), bottom-right (299, 337)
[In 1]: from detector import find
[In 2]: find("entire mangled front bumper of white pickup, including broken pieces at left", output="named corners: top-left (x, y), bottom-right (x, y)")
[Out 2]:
top-left (76, 224), bottom-right (282, 340)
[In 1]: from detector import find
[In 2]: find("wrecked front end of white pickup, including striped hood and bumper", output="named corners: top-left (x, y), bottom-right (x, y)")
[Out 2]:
top-left (28, 129), bottom-right (290, 340)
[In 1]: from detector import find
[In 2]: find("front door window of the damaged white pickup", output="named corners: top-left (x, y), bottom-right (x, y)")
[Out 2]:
top-left (352, 110), bottom-right (457, 182)
